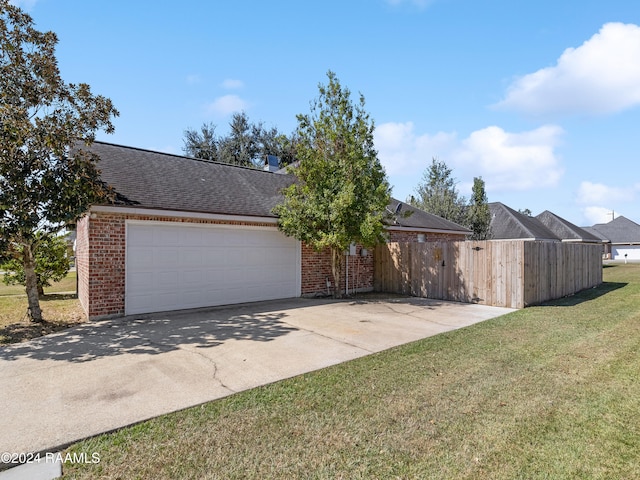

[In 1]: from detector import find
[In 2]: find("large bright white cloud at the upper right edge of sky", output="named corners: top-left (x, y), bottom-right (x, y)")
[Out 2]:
top-left (497, 23), bottom-right (640, 115)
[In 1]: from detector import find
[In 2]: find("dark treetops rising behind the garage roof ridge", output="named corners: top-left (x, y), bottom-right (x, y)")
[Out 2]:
top-left (183, 112), bottom-right (298, 168)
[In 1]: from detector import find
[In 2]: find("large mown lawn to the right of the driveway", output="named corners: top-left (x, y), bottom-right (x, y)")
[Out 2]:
top-left (64, 265), bottom-right (640, 480)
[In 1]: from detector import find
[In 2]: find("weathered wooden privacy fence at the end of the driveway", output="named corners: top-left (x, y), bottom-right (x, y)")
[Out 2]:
top-left (374, 240), bottom-right (602, 308)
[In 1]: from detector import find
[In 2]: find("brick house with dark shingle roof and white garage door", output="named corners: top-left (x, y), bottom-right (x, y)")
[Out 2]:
top-left (76, 142), bottom-right (469, 319)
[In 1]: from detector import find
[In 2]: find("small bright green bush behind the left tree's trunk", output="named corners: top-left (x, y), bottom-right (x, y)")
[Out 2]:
top-left (0, 231), bottom-right (70, 295)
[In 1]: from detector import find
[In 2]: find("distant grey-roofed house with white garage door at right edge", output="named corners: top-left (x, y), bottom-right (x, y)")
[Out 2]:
top-left (585, 216), bottom-right (640, 260)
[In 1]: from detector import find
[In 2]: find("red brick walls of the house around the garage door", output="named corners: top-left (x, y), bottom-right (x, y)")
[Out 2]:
top-left (76, 212), bottom-right (464, 319)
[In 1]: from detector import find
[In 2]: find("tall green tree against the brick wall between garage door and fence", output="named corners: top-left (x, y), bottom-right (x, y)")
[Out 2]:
top-left (274, 71), bottom-right (390, 297)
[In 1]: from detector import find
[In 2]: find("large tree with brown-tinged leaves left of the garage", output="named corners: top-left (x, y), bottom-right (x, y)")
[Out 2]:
top-left (0, 0), bottom-right (118, 322)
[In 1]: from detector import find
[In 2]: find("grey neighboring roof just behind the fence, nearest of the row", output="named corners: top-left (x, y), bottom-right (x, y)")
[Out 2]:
top-left (489, 202), bottom-right (560, 241)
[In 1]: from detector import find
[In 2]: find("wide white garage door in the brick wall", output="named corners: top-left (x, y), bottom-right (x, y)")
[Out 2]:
top-left (125, 222), bottom-right (300, 315)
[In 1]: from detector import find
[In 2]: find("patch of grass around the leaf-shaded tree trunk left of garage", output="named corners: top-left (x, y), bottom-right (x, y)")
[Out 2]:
top-left (0, 272), bottom-right (86, 345)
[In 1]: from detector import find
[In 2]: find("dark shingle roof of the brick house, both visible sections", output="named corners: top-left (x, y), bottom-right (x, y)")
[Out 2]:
top-left (84, 142), bottom-right (470, 234)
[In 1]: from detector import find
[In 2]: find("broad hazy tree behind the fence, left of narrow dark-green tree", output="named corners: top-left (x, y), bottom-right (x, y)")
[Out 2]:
top-left (409, 158), bottom-right (466, 225)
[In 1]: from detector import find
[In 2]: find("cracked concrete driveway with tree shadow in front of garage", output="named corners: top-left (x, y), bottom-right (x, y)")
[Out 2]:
top-left (0, 297), bottom-right (512, 453)
